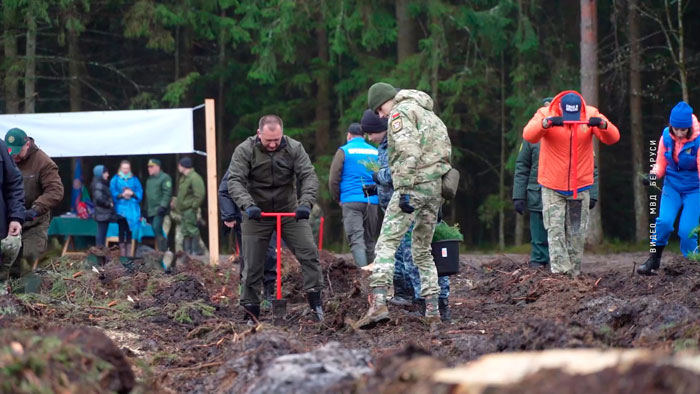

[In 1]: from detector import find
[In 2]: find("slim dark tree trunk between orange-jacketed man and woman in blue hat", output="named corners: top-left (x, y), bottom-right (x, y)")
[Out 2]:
top-left (627, 0), bottom-right (649, 242)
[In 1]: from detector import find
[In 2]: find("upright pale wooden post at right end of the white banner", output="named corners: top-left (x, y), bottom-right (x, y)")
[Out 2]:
top-left (204, 99), bottom-right (219, 265)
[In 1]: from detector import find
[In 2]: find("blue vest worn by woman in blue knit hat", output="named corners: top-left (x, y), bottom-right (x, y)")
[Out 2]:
top-left (662, 127), bottom-right (700, 193)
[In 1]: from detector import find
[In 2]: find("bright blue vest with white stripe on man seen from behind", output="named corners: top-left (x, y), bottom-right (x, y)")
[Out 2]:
top-left (329, 138), bottom-right (379, 204)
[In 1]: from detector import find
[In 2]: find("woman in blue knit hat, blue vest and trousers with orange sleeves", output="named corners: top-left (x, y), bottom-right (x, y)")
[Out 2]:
top-left (637, 101), bottom-right (700, 275)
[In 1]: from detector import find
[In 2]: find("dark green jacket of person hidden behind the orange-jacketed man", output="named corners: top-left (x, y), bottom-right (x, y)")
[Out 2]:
top-left (513, 141), bottom-right (598, 212)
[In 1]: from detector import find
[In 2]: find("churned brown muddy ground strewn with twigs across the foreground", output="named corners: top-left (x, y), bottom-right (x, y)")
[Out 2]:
top-left (0, 251), bottom-right (700, 393)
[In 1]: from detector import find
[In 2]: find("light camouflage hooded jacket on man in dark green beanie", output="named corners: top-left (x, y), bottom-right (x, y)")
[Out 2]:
top-left (387, 90), bottom-right (452, 192)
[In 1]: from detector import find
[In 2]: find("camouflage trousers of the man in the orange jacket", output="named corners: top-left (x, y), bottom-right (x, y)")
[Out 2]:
top-left (542, 187), bottom-right (590, 276)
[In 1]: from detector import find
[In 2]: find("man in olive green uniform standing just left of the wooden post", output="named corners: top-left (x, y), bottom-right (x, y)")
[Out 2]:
top-left (176, 157), bottom-right (206, 255)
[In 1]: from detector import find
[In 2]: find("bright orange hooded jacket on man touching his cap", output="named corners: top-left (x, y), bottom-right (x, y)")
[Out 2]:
top-left (523, 90), bottom-right (620, 194)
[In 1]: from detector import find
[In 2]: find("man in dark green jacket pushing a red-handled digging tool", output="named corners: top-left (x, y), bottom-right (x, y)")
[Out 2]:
top-left (228, 115), bottom-right (323, 321)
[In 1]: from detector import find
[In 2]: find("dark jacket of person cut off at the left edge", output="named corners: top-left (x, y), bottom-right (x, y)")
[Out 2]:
top-left (0, 141), bottom-right (24, 239)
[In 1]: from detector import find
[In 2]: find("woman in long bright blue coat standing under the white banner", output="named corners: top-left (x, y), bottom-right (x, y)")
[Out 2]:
top-left (109, 160), bottom-right (143, 255)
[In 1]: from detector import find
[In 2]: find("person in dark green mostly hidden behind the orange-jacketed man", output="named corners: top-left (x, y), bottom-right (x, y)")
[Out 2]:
top-left (513, 97), bottom-right (598, 268)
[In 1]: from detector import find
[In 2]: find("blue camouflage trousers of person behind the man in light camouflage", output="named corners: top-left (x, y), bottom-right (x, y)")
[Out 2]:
top-left (394, 226), bottom-right (450, 299)
